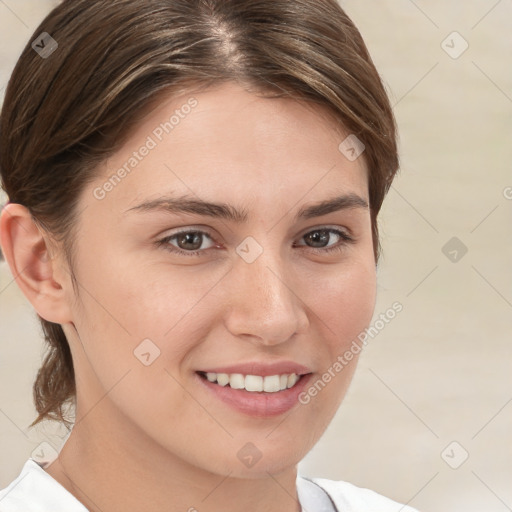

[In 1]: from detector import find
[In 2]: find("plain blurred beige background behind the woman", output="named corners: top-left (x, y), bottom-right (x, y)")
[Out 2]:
top-left (0, 0), bottom-right (512, 512)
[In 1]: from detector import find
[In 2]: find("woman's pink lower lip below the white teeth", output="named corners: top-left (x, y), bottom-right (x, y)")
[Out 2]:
top-left (196, 373), bottom-right (313, 418)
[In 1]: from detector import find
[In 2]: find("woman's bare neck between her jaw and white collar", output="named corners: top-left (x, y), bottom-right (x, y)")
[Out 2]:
top-left (46, 397), bottom-right (301, 512)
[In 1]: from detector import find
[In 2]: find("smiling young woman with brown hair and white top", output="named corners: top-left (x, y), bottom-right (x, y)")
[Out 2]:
top-left (0, 0), bottom-right (418, 512)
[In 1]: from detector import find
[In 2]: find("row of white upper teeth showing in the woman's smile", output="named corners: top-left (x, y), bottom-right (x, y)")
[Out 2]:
top-left (202, 372), bottom-right (300, 393)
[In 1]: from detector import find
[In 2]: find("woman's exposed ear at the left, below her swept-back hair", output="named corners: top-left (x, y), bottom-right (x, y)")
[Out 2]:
top-left (0, 203), bottom-right (72, 324)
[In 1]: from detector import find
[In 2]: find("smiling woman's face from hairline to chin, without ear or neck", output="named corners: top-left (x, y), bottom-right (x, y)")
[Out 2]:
top-left (65, 84), bottom-right (376, 477)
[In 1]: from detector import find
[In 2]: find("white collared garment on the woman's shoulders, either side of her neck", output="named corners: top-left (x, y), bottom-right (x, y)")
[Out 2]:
top-left (0, 458), bottom-right (417, 512)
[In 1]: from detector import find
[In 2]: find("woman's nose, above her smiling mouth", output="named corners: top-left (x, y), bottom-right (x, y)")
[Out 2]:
top-left (225, 251), bottom-right (309, 345)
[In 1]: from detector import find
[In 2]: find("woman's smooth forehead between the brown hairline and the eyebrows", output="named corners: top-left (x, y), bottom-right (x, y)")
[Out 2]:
top-left (85, 83), bottom-right (368, 216)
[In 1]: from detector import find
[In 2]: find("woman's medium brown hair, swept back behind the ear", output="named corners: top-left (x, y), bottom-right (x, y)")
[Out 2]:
top-left (0, 0), bottom-right (398, 426)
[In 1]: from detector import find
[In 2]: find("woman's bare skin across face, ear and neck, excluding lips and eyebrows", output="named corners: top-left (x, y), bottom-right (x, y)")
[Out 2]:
top-left (1, 83), bottom-right (376, 512)
